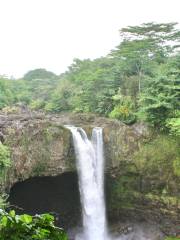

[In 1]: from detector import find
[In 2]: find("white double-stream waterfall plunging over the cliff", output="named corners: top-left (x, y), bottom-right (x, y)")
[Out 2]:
top-left (67, 126), bottom-right (107, 240)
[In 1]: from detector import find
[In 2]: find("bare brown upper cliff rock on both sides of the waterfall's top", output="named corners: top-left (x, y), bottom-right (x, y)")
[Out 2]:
top-left (0, 114), bottom-right (148, 188)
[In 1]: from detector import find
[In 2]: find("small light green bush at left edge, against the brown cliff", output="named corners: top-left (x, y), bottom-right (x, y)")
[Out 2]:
top-left (0, 142), bottom-right (11, 177)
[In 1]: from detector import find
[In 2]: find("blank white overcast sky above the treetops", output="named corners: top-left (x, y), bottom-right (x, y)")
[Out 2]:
top-left (0, 0), bottom-right (180, 77)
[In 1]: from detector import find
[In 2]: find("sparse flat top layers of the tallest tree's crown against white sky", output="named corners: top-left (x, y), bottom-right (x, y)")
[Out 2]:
top-left (120, 22), bottom-right (180, 57)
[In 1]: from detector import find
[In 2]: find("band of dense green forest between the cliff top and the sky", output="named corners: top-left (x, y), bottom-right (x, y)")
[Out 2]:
top-left (0, 23), bottom-right (180, 135)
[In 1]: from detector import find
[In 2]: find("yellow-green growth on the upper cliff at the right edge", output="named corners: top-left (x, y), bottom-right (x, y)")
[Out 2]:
top-left (134, 135), bottom-right (180, 192)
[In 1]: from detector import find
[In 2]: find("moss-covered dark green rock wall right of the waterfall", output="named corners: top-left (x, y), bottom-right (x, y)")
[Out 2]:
top-left (107, 135), bottom-right (180, 236)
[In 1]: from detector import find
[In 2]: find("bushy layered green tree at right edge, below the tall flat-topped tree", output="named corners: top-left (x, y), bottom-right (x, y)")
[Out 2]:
top-left (139, 70), bottom-right (179, 130)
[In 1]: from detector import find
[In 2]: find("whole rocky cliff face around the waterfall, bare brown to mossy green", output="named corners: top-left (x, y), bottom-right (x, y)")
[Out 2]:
top-left (0, 113), bottom-right (180, 235)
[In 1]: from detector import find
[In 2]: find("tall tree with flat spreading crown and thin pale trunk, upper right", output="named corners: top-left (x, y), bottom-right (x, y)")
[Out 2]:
top-left (111, 23), bottom-right (180, 93)
